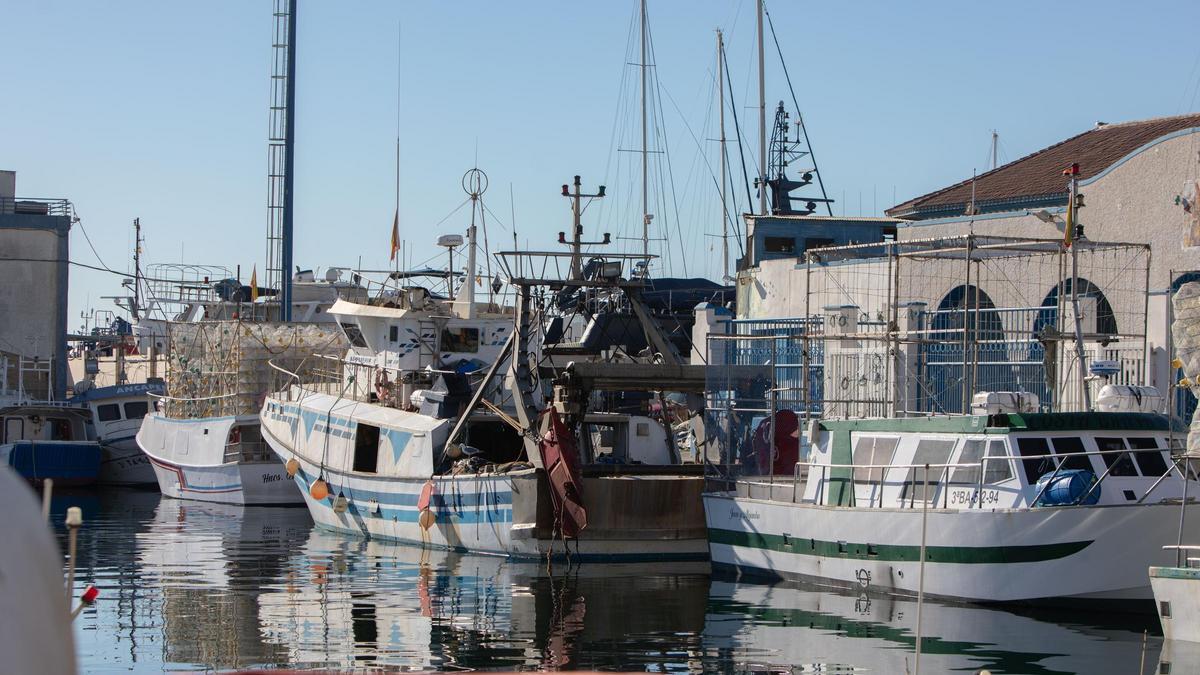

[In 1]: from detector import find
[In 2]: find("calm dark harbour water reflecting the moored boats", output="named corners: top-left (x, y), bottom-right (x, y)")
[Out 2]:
top-left (54, 490), bottom-right (1185, 674)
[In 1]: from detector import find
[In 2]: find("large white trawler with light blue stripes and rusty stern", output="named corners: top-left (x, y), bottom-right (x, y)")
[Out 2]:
top-left (262, 169), bottom-right (707, 560)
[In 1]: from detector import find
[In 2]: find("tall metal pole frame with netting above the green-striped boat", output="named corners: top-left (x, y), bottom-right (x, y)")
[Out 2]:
top-left (707, 235), bottom-right (1150, 461)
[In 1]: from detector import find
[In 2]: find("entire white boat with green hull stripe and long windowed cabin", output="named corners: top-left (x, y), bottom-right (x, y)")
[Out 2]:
top-left (704, 412), bottom-right (1200, 602)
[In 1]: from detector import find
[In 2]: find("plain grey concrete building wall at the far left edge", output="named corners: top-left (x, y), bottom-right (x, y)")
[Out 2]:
top-left (0, 214), bottom-right (71, 398)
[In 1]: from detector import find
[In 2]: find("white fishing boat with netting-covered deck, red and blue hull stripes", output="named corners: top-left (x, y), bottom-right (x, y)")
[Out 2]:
top-left (137, 321), bottom-right (343, 504)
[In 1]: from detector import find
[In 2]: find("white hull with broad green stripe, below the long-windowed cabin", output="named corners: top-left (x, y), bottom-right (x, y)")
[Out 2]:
top-left (704, 492), bottom-right (1200, 602)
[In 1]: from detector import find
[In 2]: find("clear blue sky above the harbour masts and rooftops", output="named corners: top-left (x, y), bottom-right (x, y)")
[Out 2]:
top-left (0, 0), bottom-right (1200, 325)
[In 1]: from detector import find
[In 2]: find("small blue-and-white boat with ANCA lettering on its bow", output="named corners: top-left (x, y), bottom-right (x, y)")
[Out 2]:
top-left (71, 381), bottom-right (164, 485)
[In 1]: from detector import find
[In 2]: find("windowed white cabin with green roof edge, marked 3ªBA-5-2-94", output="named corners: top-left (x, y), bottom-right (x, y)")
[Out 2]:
top-left (796, 412), bottom-right (1195, 509)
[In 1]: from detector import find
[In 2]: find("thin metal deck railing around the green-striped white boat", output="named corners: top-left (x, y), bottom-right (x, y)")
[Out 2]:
top-left (758, 448), bottom-right (1186, 508)
